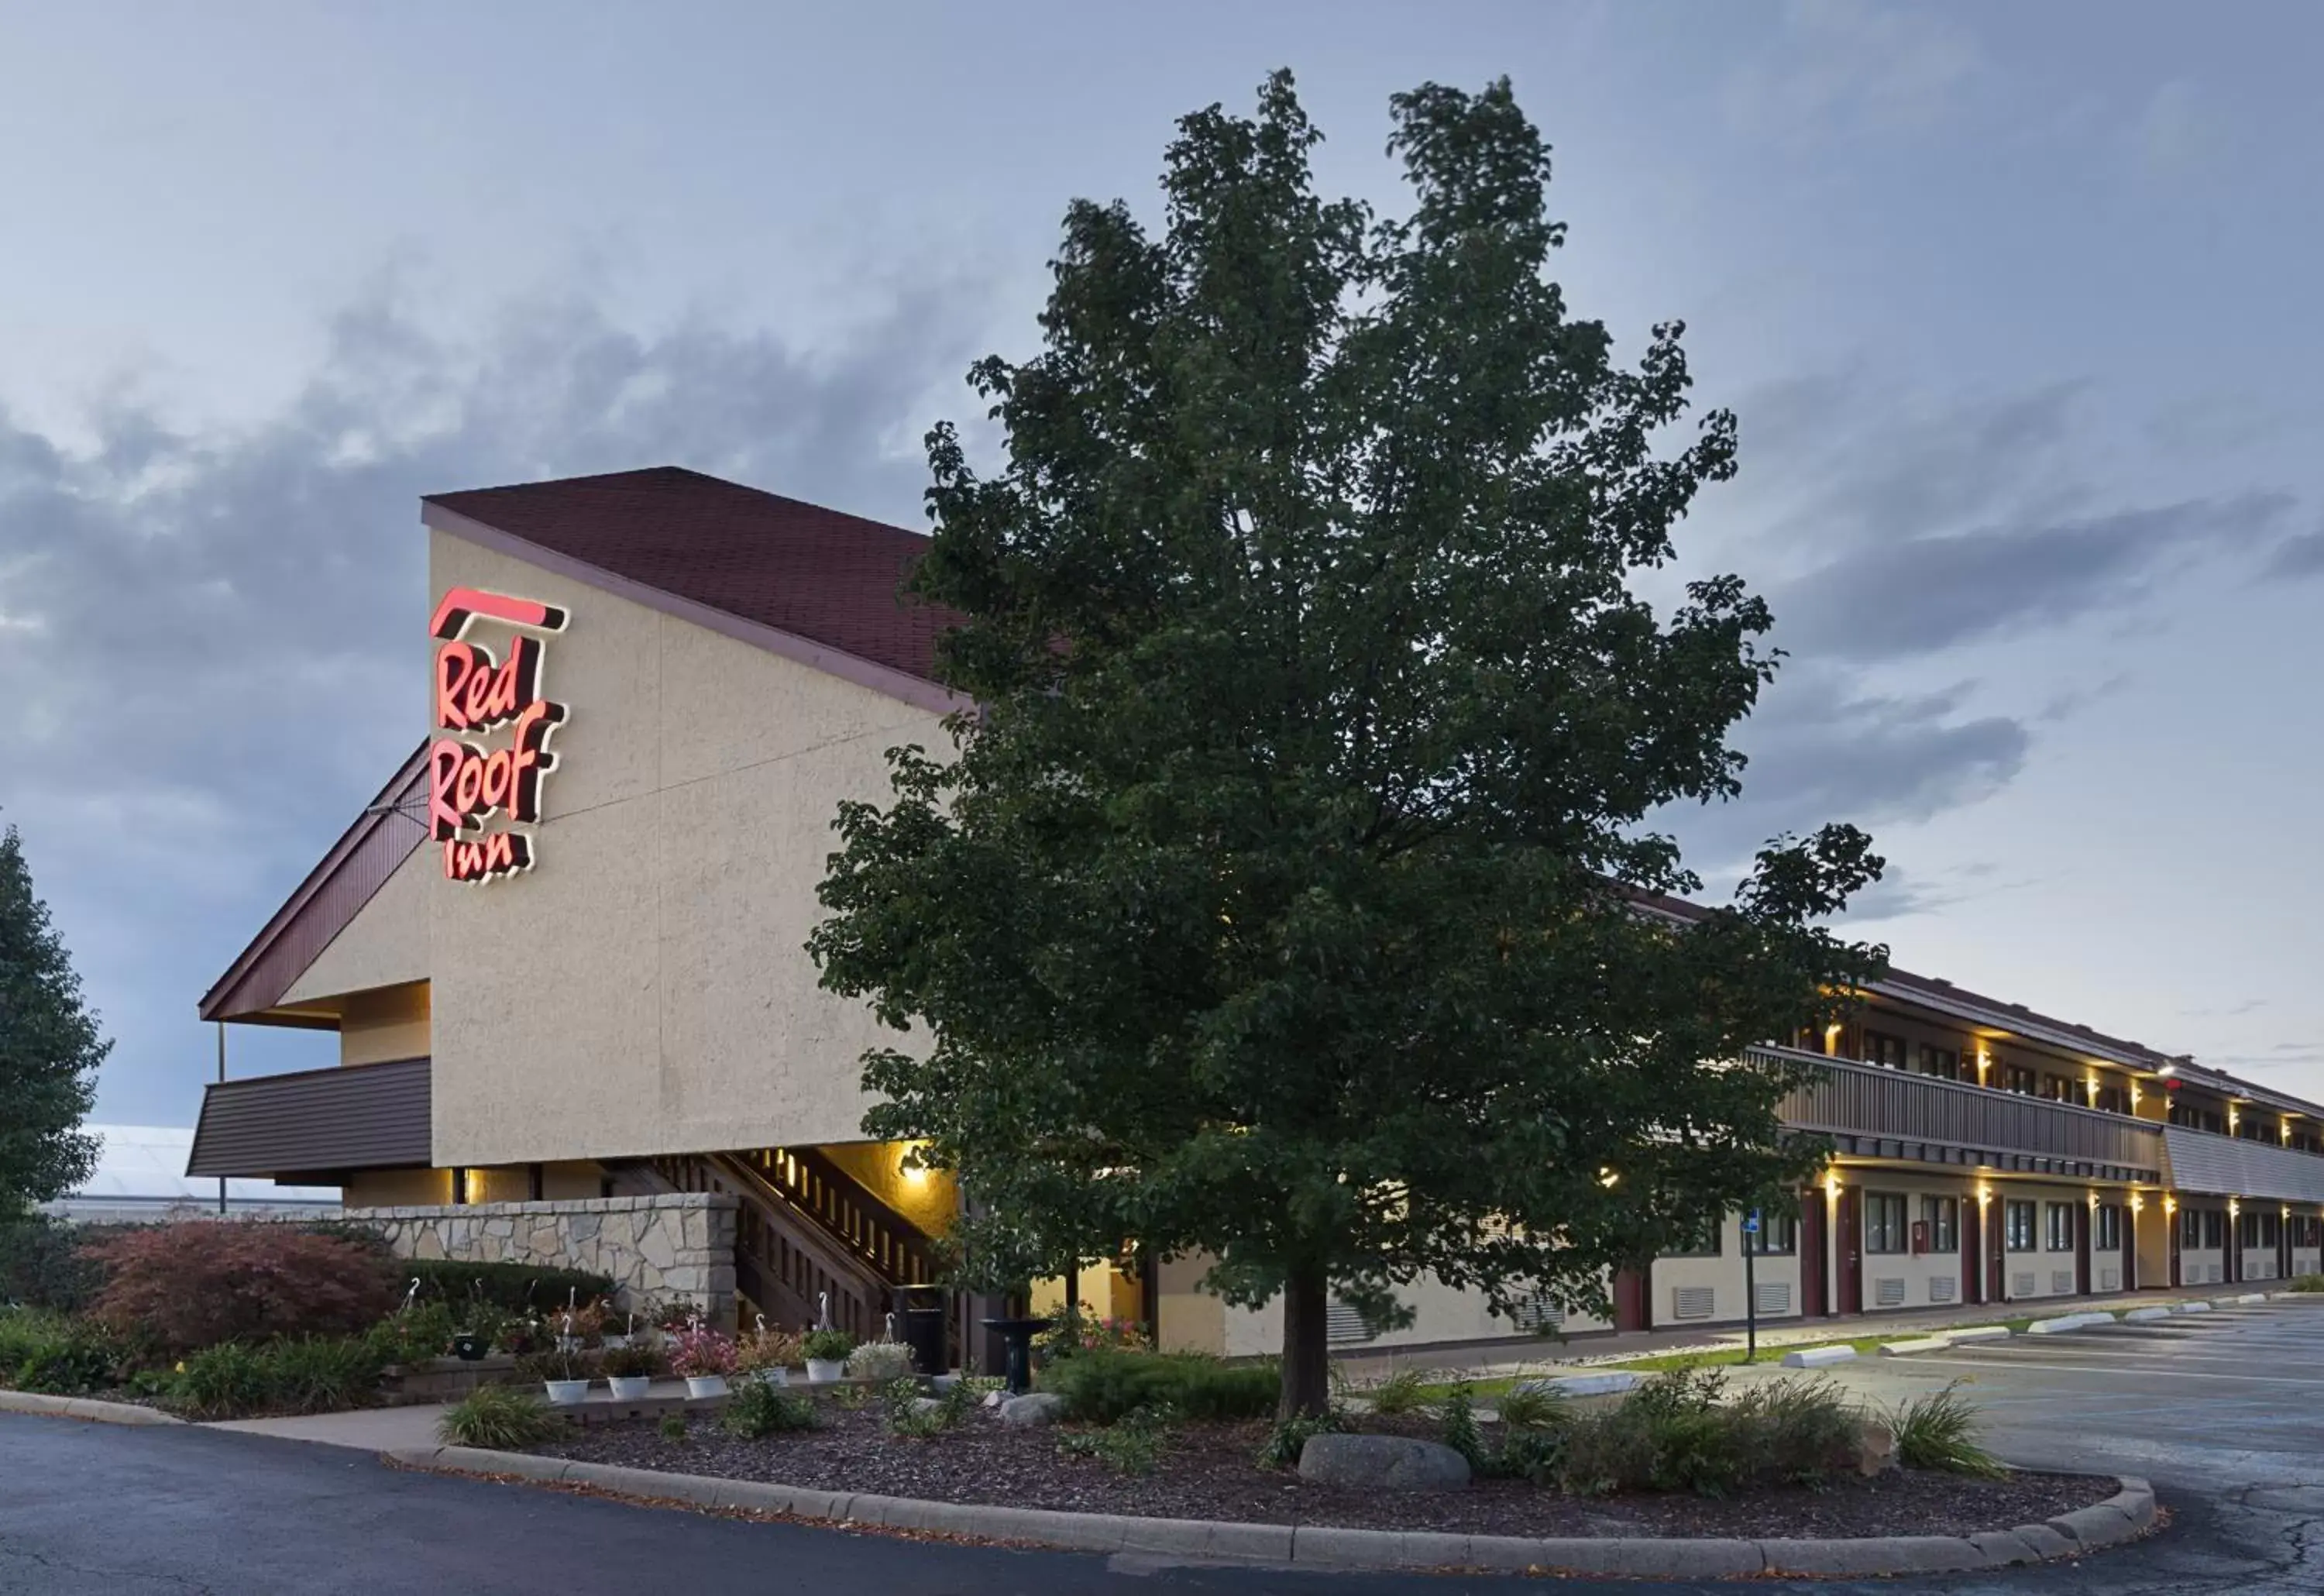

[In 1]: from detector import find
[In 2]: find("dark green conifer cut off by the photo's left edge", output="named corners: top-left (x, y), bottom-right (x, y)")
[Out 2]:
top-left (0, 827), bottom-right (112, 1219)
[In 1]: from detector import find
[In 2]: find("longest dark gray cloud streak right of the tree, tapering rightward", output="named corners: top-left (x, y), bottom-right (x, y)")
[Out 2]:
top-left (1771, 493), bottom-right (2294, 660)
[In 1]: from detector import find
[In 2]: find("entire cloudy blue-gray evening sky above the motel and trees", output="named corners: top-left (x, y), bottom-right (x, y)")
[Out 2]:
top-left (0, 0), bottom-right (2324, 1124)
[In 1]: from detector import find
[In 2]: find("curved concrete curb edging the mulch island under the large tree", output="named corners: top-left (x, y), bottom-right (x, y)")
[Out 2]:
top-left (386, 1447), bottom-right (2154, 1580)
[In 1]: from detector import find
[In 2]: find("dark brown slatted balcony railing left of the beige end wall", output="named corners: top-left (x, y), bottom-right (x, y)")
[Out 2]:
top-left (186, 1059), bottom-right (430, 1175)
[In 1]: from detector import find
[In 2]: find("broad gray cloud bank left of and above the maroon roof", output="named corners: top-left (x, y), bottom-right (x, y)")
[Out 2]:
top-left (0, 286), bottom-right (985, 1122)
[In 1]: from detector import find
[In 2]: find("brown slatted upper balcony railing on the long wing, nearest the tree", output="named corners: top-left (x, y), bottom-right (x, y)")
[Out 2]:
top-left (1748, 1047), bottom-right (2164, 1180)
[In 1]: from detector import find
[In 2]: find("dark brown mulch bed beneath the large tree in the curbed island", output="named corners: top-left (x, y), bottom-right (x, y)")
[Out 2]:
top-left (539, 1398), bottom-right (2119, 1540)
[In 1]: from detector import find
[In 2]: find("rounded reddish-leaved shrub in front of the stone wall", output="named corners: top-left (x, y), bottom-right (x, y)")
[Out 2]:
top-left (88, 1219), bottom-right (395, 1354)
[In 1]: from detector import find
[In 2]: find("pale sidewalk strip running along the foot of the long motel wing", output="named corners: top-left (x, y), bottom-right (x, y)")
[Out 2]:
top-left (1339, 1280), bottom-right (2212, 1380)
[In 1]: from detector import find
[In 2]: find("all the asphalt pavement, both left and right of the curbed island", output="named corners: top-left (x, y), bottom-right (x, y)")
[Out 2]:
top-left (0, 1303), bottom-right (2324, 1596)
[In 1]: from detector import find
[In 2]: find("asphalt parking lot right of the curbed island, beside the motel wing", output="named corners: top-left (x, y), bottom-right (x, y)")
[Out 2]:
top-left (1738, 1298), bottom-right (2324, 1596)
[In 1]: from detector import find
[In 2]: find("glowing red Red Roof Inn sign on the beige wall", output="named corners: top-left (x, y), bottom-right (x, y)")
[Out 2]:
top-left (428, 588), bottom-right (565, 880)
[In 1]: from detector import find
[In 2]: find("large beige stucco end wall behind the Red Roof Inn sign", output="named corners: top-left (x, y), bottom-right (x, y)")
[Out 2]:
top-left (414, 532), bottom-right (951, 1164)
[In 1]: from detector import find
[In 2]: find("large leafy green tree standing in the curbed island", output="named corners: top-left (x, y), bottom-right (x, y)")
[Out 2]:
top-left (811, 74), bottom-right (1880, 1412)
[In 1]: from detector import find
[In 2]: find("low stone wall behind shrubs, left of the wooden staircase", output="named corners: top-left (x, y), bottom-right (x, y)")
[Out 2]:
top-left (342, 1192), bottom-right (734, 1324)
